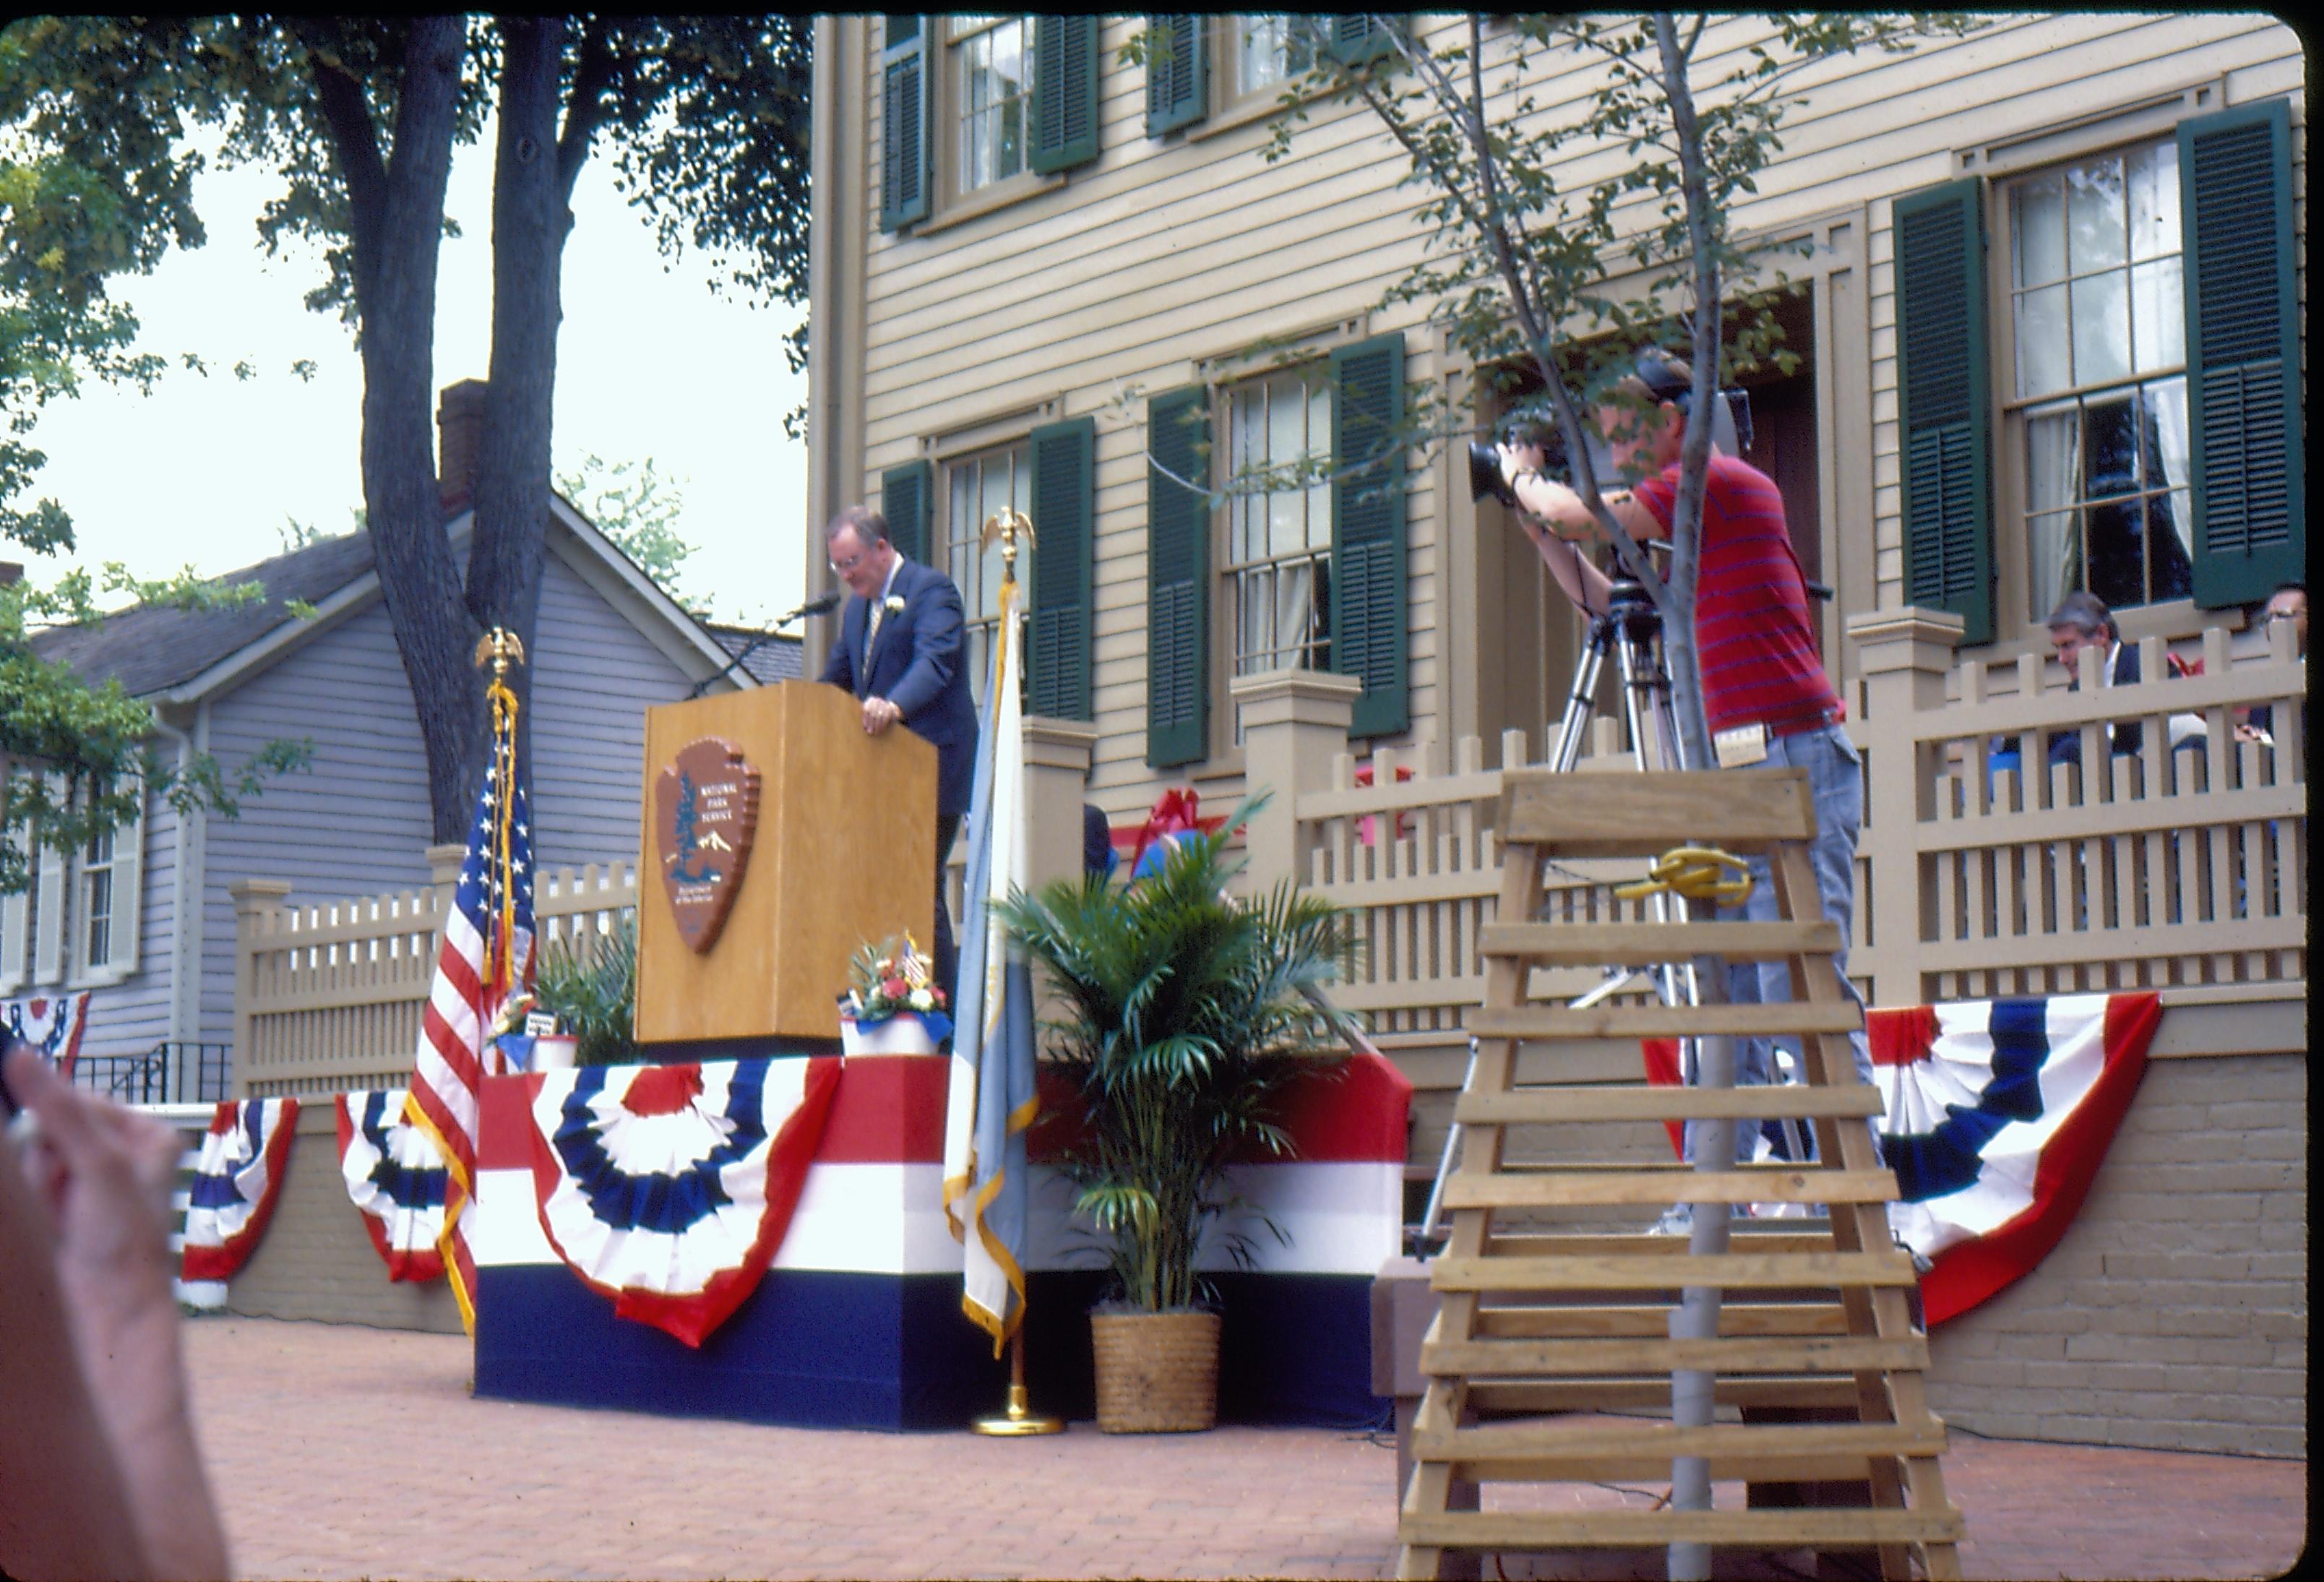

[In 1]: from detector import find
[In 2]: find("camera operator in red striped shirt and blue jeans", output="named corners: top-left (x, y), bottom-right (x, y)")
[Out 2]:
top-left (1499, 353), bottom-right (1878, 1231)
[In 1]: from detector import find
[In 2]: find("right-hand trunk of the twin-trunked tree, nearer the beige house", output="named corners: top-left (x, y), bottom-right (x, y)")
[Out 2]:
top-left (467, 17), bottom-right (572, 773)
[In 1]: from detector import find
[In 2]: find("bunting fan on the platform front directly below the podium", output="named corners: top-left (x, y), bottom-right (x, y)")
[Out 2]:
top-left (532, 1057), bottom-right (839, 1347)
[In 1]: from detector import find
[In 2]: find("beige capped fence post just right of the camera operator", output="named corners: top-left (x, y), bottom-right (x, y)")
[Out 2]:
top-left (1848, 604), bottom-right (1961, 1006)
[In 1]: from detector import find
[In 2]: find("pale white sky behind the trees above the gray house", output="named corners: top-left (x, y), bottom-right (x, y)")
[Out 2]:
top-left (9, 123), bottom-right (806, 622)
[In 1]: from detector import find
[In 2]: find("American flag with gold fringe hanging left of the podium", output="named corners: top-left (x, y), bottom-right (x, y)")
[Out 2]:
top-left (405, 765), bottom-right (532, 1333)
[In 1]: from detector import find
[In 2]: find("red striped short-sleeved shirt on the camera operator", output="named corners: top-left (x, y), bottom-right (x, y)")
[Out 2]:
top-left (1634, 455), bottom-right (1841, 736)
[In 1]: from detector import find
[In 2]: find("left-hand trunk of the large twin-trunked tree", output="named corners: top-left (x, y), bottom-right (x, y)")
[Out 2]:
top-left (343, 17), bottom-right (483, 841)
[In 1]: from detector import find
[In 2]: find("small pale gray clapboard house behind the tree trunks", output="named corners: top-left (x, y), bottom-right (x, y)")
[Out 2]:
top-left (0, 437), bottom-right (799, 1099)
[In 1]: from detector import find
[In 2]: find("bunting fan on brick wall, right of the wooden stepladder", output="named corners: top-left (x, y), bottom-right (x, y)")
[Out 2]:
top-left (1866, 994), bottom-right (2161, 1326)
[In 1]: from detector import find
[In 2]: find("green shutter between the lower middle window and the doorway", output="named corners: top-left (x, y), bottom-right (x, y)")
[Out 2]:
top-left (1332, 335), bottom-right (1413, 736)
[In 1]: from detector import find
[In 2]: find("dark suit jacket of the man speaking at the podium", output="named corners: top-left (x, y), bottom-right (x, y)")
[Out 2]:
top-left (820, 560), bottom-right (976, 813)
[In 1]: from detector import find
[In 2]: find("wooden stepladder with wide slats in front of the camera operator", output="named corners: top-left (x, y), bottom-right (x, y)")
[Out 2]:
top-left (1397, 769), bottom-right (1961, 1578)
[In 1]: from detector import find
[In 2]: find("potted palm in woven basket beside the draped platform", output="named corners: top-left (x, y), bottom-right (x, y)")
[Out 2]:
top-left (1002, 801), bottom-right (1348, 1433)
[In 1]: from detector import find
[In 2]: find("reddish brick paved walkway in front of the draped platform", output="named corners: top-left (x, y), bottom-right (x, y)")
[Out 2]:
top-left (186, 1317), bottom-right (2307, 1580)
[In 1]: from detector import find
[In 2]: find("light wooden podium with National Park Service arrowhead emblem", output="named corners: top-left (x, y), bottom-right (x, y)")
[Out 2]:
top-left (637, 681), bottom-right (937, 1043)
